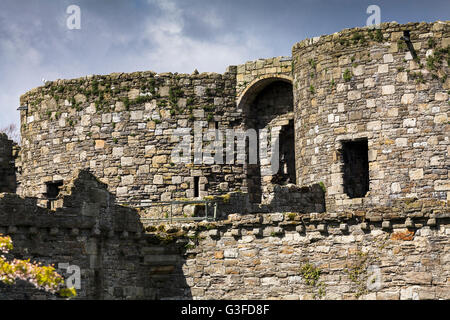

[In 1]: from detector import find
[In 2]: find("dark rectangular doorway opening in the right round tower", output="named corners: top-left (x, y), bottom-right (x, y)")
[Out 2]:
top-left (342, 139), bottom-right (369, 198)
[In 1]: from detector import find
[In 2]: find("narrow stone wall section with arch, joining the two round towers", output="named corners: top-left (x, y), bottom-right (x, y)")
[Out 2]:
top-left (236, 57), bottom-right (295, 204)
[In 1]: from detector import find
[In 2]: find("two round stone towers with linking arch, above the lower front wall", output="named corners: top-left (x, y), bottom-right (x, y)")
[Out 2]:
top-left (18, 22), bottom-right (450, 214)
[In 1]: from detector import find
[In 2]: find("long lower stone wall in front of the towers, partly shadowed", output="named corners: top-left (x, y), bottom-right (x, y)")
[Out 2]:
top-left (0, 171), bottom-right (450, 300)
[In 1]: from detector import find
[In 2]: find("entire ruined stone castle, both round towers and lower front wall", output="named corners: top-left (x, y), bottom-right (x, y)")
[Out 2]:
top-left (0, 21), bottom-right (450, 299)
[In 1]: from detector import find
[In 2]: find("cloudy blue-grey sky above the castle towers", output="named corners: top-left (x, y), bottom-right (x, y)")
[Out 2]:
top-left (0, 0), bottom-right (450, 128)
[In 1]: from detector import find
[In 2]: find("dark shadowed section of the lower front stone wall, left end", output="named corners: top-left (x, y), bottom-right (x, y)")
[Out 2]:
top-left (0, 171), bottom-right (192, 299)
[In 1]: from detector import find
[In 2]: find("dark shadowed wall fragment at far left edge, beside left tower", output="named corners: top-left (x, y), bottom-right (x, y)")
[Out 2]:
top-left (0, 133), bottom-right (18, 193)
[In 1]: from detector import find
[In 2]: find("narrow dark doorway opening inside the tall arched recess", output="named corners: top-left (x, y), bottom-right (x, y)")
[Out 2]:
top-left (273, 120), bottom-right (296, 185)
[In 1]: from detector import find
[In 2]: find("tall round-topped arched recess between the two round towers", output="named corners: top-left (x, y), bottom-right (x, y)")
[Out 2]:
top-left (238, 75), bottom-right (296, 203)
